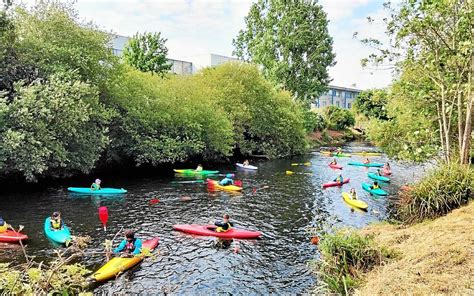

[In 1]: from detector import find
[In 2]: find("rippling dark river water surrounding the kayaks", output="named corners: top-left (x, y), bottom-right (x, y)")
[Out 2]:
top-left (0, 143), bottom-right (423, 295)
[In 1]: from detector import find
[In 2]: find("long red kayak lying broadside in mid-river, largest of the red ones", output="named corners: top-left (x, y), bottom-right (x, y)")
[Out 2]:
top-left (173, 224), bottom-right (262, 239)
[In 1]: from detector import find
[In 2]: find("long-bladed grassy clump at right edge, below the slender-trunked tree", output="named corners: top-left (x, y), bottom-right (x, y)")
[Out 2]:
top-left (399, 163), bottom-right (474, 222)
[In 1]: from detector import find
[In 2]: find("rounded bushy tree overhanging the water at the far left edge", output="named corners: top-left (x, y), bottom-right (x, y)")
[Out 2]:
top-left (0, 73), bottom-right (110, 181)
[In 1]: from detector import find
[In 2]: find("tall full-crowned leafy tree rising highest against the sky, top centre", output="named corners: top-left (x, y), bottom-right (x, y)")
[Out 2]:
top-left (233, 0), bottom-right (335, 102)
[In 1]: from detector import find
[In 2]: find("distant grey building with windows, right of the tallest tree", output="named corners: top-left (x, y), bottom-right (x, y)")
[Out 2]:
top-left (311, 85), bottom-right (362, 109)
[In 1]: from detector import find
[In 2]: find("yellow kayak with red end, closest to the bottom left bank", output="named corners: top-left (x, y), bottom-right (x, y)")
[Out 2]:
top-left (92, 237), bottom-right (159, 282)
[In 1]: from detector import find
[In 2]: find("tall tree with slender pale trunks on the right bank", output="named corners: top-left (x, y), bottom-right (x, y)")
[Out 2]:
top-left (363, 0), bottom-right (474, 164)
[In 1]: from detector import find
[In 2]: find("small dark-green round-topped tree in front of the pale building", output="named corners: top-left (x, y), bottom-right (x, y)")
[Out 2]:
top-left (123, 32), bottom-right (172, 77)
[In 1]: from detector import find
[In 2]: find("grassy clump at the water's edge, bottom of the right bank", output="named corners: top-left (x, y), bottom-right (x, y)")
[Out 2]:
top-left (317, 230), bottom-right (395, 295)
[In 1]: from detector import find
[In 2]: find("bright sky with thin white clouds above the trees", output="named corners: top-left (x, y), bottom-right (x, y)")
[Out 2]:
top-left (26, 0), bottom-right (391, 89)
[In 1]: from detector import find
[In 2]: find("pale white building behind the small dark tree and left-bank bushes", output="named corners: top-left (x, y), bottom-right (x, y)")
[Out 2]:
top-left (111, 34), bottom-right (238, 75)
